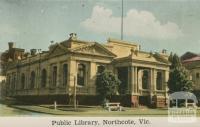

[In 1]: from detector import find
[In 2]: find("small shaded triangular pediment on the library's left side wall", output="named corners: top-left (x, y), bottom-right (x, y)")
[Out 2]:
top-left (48, 44), bottom-right (67, 57)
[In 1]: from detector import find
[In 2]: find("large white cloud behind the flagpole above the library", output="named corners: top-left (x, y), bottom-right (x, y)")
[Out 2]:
top-left (81, 5), bottom-right (183, 39)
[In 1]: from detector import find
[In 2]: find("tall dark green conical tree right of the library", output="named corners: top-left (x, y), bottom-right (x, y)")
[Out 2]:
top-left (168, 53), bottom-right (193, 93)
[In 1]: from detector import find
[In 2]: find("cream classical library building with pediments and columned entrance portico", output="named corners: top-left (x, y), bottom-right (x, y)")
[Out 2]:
top-left (3, 33), bottom-right (170, 107)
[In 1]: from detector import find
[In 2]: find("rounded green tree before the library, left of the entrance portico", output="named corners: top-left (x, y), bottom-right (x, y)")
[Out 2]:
top-left (96, 70), bottom-right (120, 101)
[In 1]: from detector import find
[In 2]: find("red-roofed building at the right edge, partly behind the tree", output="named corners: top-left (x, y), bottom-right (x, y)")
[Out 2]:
top-left (181, 52), bottom-right (200, 91)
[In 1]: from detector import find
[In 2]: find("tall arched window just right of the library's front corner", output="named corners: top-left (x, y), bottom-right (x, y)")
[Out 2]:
top-left (77, 64), bottom-right (86, 86)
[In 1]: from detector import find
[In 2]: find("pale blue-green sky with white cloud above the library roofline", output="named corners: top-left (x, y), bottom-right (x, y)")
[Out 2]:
top-left (0, 0), bottom-right (200, 55)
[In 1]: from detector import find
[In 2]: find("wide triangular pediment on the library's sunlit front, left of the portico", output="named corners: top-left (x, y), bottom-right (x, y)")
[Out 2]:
top-left (72, 43), bottom-right (116, 57)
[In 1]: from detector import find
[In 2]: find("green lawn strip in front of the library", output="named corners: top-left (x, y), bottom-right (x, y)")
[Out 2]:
top-left (9, 105), bottom-right (200, 117)
